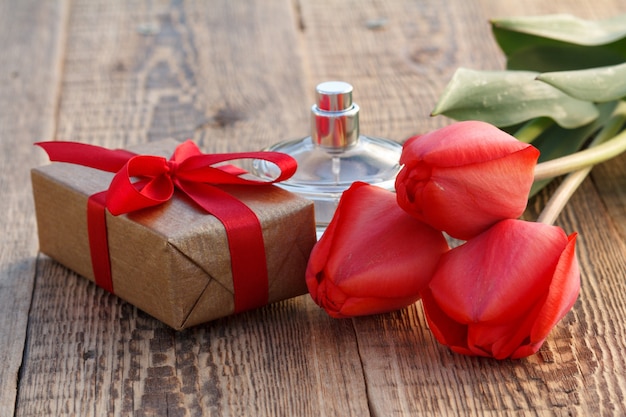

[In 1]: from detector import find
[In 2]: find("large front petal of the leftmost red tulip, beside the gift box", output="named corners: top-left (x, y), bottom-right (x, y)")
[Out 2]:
top-left (326, 185), bottom-right (447, 298)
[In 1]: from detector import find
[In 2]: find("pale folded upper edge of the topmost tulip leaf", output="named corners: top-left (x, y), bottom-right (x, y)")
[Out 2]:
top-left (491, 14), bottom-right (626, 46)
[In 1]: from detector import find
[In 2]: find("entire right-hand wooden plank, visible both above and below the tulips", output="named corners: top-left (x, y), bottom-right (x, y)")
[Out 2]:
top-left (302, 1), bottom-right (626, 416)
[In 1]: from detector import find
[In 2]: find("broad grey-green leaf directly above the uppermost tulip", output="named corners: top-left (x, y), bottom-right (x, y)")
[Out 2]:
top-left (432, 68), bottom-right (598, 128)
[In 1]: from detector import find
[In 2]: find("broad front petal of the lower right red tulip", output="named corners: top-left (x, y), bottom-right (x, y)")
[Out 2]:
top-left (430, 220), bottom-right (567, 324)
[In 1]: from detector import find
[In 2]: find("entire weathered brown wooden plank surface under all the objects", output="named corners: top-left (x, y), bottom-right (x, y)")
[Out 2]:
top-left (0, 0), bottom-right (626, 416)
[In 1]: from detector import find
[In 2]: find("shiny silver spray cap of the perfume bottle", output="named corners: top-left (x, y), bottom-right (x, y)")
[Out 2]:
top-left (311, 81), bottom-right (359, 152)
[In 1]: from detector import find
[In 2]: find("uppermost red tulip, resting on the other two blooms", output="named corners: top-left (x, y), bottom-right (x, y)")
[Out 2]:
top-left (396, 121), bottom-right (539, 240)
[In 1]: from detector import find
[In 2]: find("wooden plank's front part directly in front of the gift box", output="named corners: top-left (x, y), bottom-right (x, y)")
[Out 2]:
top-left (18, 257), bottom-right (367, 416)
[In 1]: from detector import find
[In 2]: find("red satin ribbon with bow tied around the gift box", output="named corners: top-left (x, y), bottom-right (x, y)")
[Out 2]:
top-left (37, 141), bottom-right (297, 312)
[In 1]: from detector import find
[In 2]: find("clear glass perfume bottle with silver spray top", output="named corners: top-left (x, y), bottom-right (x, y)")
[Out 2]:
top-left (252, 81), bottom-right (402, 238)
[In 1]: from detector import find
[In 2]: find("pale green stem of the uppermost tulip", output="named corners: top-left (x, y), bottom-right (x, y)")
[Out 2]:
top-left (535, 105), bottom-right (626, 181)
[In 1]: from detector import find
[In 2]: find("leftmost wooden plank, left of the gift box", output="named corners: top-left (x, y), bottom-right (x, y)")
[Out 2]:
top-left (0, 1), bottom-right (67, 416)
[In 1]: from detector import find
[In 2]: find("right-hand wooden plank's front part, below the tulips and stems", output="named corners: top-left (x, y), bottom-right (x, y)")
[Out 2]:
top-left (354, 177), bottom-right (626, 416)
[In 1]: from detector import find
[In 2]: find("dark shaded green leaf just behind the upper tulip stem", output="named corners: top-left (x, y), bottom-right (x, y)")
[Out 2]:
top-left (530, 101), bottom-right (617, 197)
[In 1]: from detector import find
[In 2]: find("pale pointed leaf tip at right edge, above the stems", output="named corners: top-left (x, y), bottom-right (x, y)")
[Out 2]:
top-left (537, 63), bottom-right (626, 103)
